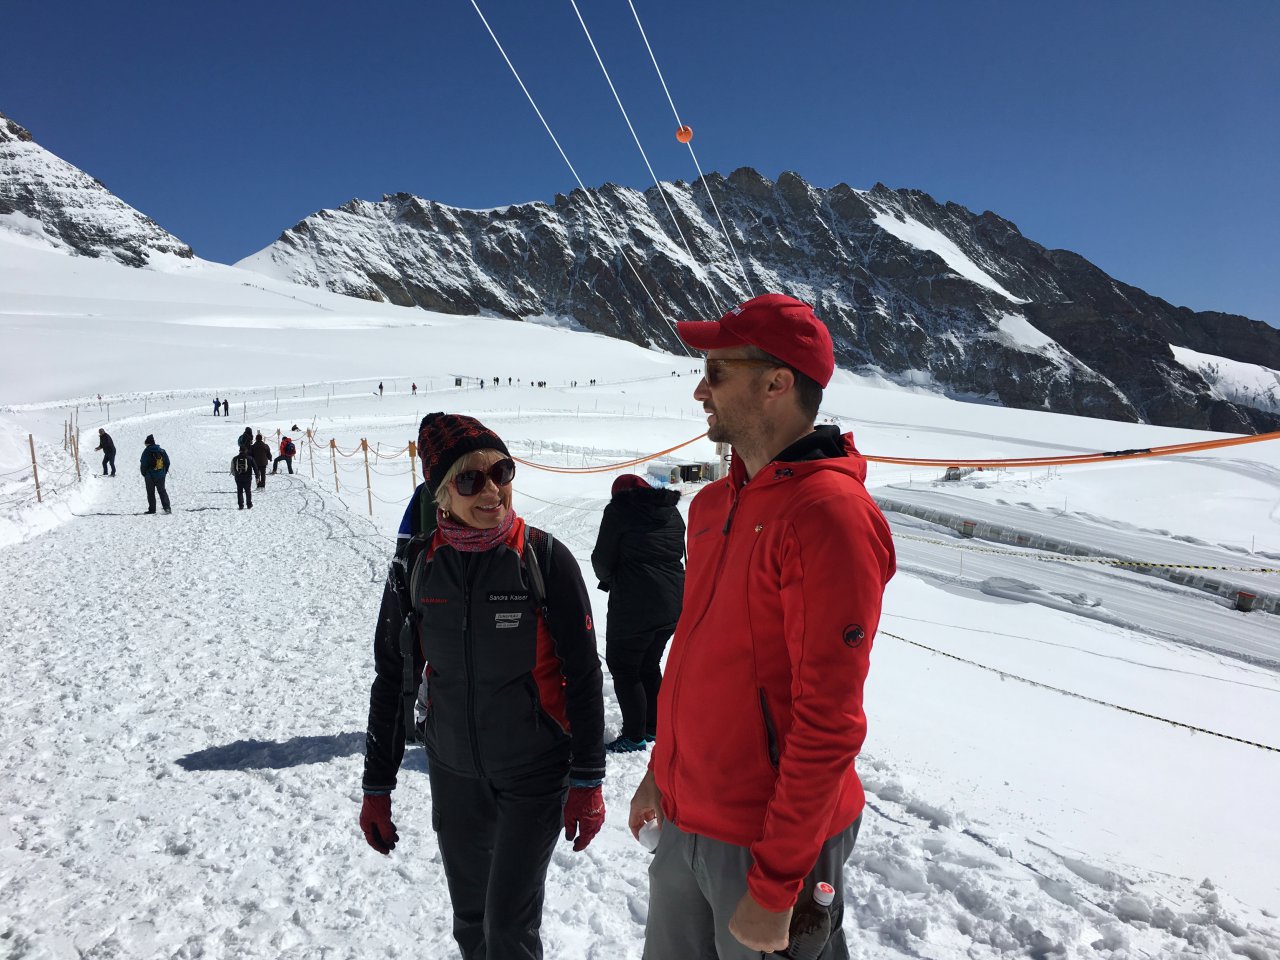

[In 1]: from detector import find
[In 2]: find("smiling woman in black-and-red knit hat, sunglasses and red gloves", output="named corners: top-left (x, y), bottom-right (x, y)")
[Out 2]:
top-left (360, 413), bottom-right (604, 960)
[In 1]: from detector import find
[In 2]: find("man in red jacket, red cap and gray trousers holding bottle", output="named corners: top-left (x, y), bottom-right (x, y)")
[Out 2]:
top-left (628, 293), bottom-right (895, 960)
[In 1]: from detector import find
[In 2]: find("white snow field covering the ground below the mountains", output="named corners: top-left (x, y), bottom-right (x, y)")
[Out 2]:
top-left (0, 235), bottom-right (1280, 960)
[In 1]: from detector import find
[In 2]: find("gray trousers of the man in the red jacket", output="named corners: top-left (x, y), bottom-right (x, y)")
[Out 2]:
top-left (644, 817), bottom-right (863, 960)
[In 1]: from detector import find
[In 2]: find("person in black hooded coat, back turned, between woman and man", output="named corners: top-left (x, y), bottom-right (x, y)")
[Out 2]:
top-left (591, 474), bottom-right (685, 753)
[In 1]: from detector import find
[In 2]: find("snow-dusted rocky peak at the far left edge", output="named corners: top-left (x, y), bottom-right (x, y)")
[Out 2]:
top-left (0, 114), bottom-right (193, 266)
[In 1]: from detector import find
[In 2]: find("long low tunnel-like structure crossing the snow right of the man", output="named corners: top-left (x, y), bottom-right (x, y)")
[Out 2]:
top-left (873, 494), bottom-right (1280, 613)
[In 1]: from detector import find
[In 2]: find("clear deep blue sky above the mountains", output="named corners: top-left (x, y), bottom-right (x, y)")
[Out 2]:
top-left (0, 0), bottom-right (1280, 324)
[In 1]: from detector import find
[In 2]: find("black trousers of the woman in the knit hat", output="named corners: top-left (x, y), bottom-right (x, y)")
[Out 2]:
top-left (428, 758), bottom-right (568, 960)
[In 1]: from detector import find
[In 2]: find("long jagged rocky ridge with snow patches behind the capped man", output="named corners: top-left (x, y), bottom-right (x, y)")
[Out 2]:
top-left (238, 168), bottom-right (1280, 433)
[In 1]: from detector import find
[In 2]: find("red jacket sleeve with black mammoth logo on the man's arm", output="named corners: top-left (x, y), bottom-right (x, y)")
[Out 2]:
top-left (748, 493), bottom-right (893, 910)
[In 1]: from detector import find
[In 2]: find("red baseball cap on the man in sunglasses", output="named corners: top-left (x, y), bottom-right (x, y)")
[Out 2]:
top-left (676, 293), bottom-right (836, 387)
